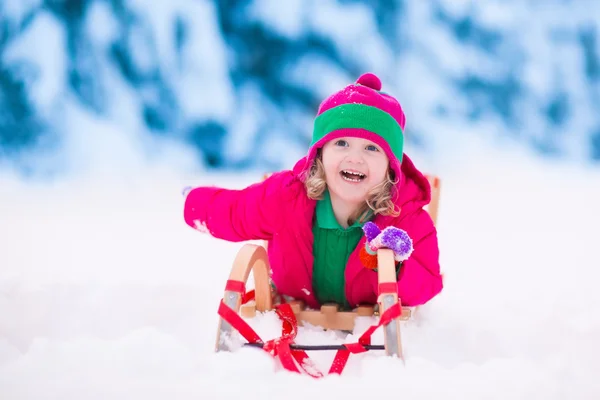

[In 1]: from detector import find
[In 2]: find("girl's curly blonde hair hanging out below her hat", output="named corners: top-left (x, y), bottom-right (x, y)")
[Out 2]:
top-left (304, 149), bottom-right (400, 225)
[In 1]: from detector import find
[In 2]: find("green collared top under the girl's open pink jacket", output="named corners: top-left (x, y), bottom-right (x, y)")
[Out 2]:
top-left (312, 190), bottom-right (364, 309)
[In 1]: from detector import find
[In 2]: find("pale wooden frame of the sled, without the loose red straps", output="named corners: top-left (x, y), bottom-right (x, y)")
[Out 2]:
top-left (215, 176), bottom-right (440, 364)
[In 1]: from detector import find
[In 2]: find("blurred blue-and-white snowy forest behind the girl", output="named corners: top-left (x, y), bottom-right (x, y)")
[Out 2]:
top-left (0, 0), bottom-right (600, 174)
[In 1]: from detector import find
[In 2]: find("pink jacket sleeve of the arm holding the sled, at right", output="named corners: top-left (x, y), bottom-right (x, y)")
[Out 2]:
top-left (390, 209), bottom-right (443, 306)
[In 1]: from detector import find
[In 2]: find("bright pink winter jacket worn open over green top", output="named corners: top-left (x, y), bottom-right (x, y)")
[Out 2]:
top-left (184, 155), bottom-right (442, 308)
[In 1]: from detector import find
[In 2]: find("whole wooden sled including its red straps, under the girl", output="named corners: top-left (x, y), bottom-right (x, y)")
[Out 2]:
top-left (216, 176), bottom-right (440, 377)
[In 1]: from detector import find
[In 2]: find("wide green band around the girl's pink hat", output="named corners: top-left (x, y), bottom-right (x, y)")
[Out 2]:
top-left (310, 103), bottom-right (404, 160)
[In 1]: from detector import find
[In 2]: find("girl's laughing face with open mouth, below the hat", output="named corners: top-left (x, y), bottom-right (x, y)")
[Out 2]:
top-left (322, 137), bottom-right (389, 206)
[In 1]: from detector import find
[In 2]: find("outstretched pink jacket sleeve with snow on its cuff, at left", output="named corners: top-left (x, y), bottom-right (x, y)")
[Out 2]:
top-left (183, 172), bottom-right (290, 242)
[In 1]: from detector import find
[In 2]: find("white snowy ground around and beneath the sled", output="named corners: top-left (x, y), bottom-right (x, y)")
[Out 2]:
top-left (0, 148), bottom-right (600, 400)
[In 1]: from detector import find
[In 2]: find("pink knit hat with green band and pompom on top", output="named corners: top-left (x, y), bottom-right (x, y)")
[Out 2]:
top-left (307, 73), bottom-right (406, 176)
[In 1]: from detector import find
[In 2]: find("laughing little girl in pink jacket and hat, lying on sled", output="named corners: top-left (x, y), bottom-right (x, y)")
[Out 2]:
top-left (184, 73), bottom-right (442, 309)
